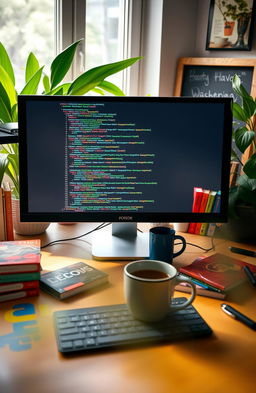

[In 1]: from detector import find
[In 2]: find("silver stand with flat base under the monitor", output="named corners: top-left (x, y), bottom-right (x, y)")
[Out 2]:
top-left (92, 223), bottom-right (149, 261)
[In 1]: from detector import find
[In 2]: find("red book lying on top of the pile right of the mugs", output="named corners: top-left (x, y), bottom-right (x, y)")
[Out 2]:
top-left (179, 253), bottom-right (256, 291)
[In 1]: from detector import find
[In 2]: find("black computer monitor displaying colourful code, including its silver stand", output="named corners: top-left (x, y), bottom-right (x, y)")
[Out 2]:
top-left (18, 95), bottom-right (232, 259)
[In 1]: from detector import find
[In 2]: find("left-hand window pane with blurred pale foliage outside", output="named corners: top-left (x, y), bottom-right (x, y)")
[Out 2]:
top-left (0, 0), bottom-right (54, 91)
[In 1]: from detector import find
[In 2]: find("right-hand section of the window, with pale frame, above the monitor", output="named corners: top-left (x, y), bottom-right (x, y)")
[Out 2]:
top-left (57, 0), bottom-right (142, 94)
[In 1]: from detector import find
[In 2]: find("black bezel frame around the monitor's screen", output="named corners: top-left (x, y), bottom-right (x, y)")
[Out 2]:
top-left (18, 95), bottom-right (232, 223)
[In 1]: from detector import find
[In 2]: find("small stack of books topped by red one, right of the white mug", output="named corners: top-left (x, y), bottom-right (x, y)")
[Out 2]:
top-left (175, 253), bottom-right (256, 299)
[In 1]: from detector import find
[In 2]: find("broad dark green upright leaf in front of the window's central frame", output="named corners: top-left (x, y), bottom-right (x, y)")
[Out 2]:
top-left (50, 40), bottom-right (81, 89)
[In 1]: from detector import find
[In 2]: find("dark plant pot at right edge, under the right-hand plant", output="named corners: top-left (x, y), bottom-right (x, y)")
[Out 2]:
top-left (216, 205), bottom-right (256, 244)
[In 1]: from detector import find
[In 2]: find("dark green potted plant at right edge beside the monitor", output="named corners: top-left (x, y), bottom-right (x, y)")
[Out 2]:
top-left (218, 75), bottom-right (256, 242)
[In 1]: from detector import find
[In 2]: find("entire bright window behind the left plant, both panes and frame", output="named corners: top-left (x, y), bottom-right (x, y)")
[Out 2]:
top-left (0, 0), bottom-right (148, 95)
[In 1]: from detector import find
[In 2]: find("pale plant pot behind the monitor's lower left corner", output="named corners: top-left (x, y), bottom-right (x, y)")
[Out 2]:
top-left (12, 199), bottom-right (50, 236)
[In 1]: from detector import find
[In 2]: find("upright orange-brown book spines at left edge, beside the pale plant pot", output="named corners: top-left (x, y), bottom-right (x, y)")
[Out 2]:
top-left (0, 184), bottom-right (14, 241)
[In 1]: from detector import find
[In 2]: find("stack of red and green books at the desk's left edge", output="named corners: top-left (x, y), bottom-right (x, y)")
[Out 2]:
top-left (0, 239), bottom-right (41, 302)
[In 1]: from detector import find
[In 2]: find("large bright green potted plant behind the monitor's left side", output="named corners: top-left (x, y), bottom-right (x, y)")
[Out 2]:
top-left (0, 41), bottom-right (140, 234)
